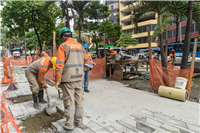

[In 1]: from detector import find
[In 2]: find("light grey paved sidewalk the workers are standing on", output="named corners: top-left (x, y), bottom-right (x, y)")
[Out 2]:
top-left (0, 67), bottom-right (200, 133)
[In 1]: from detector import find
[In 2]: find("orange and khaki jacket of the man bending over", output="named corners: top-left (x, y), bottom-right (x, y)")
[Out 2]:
top-left (28, 56), bottom-right (52, 86)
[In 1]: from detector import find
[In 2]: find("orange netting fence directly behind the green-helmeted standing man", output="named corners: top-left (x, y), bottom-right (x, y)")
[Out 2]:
top-left (45, 58), bottom-right (106, 81)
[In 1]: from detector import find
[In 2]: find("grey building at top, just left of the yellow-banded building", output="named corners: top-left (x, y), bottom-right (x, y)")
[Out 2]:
top-left (105, 0), bottom-right (119, 24)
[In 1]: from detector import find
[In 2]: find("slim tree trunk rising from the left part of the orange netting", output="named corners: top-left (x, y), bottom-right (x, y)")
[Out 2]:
top-left (159, 13), bottom-right (167, 68)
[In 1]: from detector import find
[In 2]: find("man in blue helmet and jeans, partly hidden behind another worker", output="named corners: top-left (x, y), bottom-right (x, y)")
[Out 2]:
top-left (82, 44), bottom-right (92, 93)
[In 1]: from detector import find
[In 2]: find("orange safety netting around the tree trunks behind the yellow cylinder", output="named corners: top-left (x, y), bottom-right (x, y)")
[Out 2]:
top-left (149, 59), bottom-right (194, 96)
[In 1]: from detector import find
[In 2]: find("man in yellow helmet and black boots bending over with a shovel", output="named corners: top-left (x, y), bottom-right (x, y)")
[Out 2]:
top-left (25, 56), bottom-right (56, 109)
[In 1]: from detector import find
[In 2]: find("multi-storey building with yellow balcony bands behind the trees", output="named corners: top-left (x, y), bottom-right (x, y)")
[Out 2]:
top-left (119, 0), bottom-right (158, 48)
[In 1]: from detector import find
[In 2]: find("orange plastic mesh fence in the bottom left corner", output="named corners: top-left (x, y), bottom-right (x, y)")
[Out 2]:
top-left (0, 90), bottom-right (21, 133)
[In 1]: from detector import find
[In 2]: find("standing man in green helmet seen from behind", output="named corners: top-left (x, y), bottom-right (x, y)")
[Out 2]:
top-left (55, 27), bottom-right (88, 133)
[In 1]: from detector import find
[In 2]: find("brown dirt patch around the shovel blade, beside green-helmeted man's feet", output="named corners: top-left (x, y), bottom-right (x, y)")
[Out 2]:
top-left (22, 111), bottom-right (63, 133)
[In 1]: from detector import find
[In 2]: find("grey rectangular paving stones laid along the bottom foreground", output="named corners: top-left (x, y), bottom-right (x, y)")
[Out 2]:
top-left (52, 109), bottom-right (200, 133)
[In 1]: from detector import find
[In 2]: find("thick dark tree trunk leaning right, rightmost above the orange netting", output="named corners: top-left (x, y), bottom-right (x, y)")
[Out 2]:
top-left (181, 0), bottom-right (193, 69)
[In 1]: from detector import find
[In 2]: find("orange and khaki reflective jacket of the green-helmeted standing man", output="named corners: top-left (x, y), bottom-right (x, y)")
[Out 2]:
top-left (55, 38), bottom-right (88, 82)
